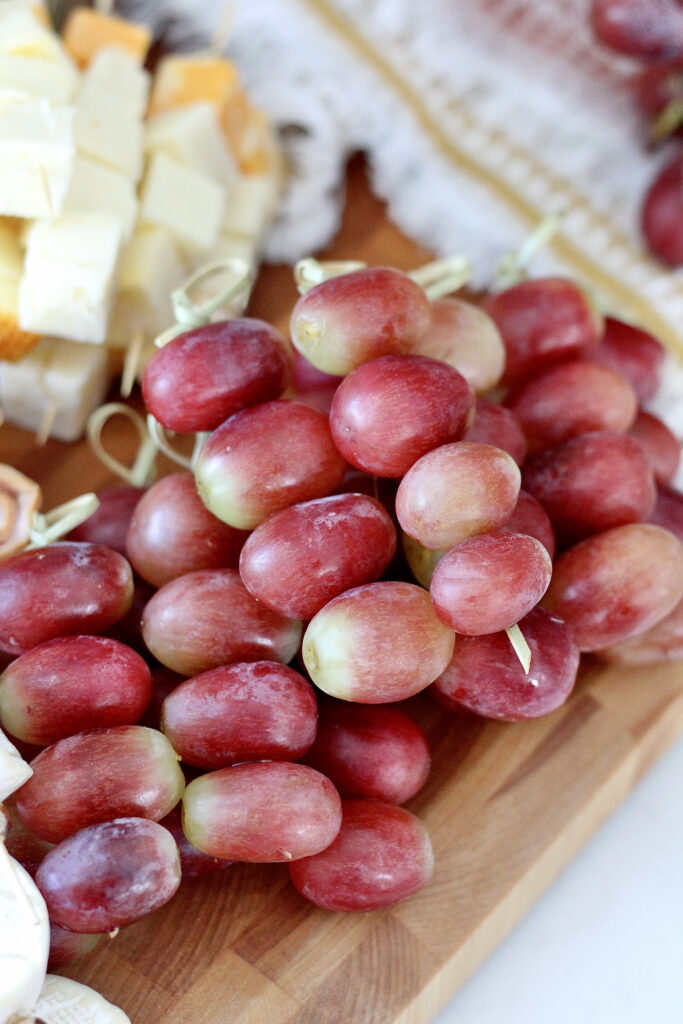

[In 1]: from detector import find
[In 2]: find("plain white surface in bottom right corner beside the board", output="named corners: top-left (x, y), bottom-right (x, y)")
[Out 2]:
top-left (433, 739), bottom-right (683, 1024)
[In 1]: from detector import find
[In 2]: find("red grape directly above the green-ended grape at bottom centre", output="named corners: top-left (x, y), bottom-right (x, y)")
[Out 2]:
top-left (162, 662), bottom-right (317, 768)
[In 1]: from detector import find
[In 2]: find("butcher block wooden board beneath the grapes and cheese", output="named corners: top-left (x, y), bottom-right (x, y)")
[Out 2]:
top-left (0, 162), bottom-right (683, 1024)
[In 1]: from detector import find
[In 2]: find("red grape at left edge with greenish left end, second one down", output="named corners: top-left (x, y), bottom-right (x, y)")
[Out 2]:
top-left (0, 636), bottom-right (152, 746)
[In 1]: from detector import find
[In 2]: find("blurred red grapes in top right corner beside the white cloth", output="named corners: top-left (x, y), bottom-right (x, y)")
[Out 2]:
top-left (591, 0), bottom-right (683, 266)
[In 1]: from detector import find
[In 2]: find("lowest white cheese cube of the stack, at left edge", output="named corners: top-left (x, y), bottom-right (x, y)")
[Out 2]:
top-left (0, 338), bottom-right (109, 441)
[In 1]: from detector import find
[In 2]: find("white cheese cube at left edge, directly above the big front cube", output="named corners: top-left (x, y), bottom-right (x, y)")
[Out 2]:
top-left (0, 93), bottom-right (75, 217)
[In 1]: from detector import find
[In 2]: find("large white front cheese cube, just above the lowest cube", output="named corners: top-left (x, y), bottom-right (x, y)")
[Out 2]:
top-left (19, 211), bottom-right (121, 344)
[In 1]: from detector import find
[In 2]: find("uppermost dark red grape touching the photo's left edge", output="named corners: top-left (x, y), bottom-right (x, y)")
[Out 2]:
top-left (0, 542), bottom-right (133, 654)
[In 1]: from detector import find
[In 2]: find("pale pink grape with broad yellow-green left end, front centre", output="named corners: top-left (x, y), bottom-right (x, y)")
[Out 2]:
top-left (302, 581), bottom-right (453, 703)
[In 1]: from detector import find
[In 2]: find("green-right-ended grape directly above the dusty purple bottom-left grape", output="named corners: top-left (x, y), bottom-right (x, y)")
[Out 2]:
top-left (15, 725), bottom-right (185, 843)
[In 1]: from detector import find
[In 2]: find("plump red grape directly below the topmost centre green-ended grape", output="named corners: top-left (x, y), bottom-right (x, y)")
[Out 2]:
top-left (330, 355), bottom-right (474, 477)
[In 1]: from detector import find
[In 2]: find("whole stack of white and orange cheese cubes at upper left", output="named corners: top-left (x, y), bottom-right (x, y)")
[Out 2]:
top-left (0, 0), bottom-right (281, 439)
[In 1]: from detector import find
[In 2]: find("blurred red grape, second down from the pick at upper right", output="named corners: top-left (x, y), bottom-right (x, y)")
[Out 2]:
top-left (506, 359), bottom-right (638, 456)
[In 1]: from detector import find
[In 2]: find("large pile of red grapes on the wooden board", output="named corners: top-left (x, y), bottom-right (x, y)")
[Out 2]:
top-left (0, 267), bottom-right (683, 968)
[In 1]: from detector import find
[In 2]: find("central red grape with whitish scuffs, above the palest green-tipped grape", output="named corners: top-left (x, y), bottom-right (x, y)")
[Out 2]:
top-left (240, 495), bottom-right (396, 620)
